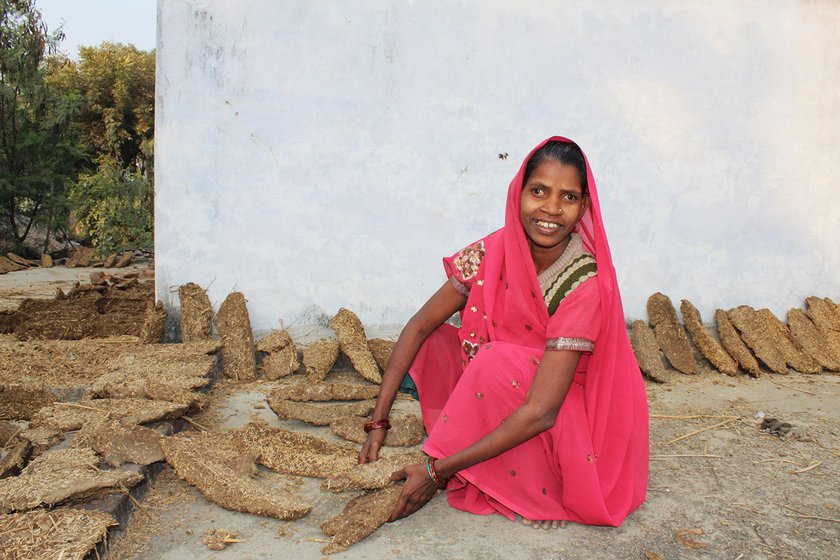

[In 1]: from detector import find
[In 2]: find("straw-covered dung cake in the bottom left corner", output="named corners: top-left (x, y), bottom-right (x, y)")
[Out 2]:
top-left (0, 508), bottom-right (117, 560)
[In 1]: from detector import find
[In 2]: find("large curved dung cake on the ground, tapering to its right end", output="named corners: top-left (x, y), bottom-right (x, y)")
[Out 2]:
top-left (162, 432), bottom-right (312, 519)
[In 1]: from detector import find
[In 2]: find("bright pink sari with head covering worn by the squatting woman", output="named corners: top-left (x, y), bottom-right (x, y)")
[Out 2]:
top-left (410, 137), bottom-right (649, 526)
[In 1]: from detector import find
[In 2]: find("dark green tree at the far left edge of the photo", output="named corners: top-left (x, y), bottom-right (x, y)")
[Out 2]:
top-left (0, 0), bottom-right (81, 246)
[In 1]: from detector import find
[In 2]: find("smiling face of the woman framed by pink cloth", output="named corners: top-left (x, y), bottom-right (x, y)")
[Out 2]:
top-left (521, 159), bottom-right (589, 262)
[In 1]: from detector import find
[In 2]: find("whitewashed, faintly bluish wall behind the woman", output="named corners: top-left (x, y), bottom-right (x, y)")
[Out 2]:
top-left (155, 0), bottom-right (840, 330)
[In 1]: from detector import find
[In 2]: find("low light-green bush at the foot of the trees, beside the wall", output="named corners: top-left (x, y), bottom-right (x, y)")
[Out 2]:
top-left (70, 156), bottom-right (154, 256)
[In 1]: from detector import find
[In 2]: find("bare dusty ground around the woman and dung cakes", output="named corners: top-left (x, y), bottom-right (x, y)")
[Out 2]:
top-left (0, 269), bottom-right (840, 560)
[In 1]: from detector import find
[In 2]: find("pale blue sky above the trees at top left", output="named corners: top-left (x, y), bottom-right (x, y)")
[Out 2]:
top-left (35, 0), bottom-right (157, 58)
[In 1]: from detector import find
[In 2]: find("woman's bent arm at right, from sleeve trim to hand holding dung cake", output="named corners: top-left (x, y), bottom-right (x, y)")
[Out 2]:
top-left (389, 350), bottom-right (580, 521)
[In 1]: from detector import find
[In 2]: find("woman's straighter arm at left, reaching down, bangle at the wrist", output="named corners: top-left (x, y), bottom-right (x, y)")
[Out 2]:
top-left (359, 281), bottom-right (467, 463)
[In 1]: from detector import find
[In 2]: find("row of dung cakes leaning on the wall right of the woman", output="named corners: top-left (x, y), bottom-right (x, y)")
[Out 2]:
top-left (630, 292), bottom-right (840, 382)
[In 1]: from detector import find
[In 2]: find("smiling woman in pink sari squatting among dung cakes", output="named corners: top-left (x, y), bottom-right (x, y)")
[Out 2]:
top-left (359, 137), bottom-right (649, 528)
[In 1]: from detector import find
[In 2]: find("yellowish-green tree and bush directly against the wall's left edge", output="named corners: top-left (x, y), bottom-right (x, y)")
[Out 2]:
top-left (64, 43), bottom-right (155, 253)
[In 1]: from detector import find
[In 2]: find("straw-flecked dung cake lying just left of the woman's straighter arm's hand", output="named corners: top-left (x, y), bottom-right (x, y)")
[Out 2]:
top-left (232, 422), bottom-right (359, 478)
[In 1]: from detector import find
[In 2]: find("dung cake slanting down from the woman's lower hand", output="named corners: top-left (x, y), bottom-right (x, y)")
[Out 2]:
top-left (321, 484), bottom-right (402, 554)
